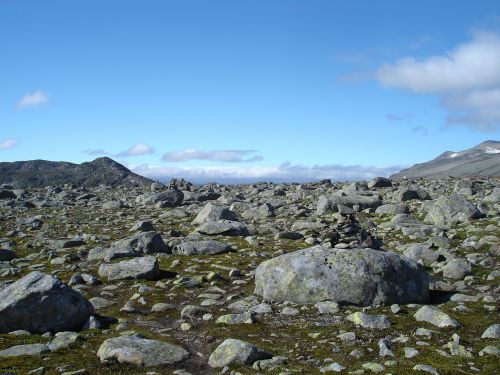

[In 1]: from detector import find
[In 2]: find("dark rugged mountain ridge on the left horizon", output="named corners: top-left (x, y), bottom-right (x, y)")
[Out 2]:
top-left (0, 157), bottom-right (153, 188)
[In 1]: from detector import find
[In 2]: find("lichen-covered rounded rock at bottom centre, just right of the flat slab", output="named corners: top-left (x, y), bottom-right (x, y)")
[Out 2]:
top-left (208, 339), bottom-right (272, 368)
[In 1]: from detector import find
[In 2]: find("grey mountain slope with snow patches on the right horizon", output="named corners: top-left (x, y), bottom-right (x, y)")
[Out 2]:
top-left (391, 141), bottom-right (500, 179)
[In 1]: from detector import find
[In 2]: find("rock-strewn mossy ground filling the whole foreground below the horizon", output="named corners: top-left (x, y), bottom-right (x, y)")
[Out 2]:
top-left (0, 177), bottom-right (500, 375)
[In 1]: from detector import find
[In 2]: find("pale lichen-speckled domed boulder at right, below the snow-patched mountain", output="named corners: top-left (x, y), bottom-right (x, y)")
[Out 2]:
top-left (425, 194), bottom-right (481, 225)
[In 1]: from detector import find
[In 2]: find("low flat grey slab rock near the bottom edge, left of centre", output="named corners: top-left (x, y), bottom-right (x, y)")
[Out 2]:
top-left (97, 335), bottom-right (189, 367)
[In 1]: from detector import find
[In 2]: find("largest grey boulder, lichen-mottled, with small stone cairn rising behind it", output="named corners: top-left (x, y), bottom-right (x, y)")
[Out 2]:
top-left (255, 246), bottom-right (429, 306)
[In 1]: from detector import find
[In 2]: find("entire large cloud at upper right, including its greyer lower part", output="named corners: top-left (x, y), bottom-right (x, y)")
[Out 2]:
top-left (377, 32), bottom-right (500, 132)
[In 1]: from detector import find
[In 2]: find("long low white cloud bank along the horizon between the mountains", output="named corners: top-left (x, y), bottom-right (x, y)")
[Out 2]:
top-left (129, 162), bottom-right (405, 183)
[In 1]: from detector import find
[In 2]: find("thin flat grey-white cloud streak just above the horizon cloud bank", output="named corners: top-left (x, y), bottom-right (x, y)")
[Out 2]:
top-left (162, 149), bottom-right (264, 163)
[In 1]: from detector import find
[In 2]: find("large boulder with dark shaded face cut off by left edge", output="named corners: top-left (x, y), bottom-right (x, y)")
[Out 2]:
top-left (0, 271), bottom-right (94, 333)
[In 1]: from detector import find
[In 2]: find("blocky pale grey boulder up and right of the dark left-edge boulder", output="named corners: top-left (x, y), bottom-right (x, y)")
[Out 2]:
top-left (99, 256), bottom-right (160, 281)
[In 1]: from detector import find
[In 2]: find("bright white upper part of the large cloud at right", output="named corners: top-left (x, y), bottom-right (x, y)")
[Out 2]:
top-left (377, 32), bottom-right (500, 93)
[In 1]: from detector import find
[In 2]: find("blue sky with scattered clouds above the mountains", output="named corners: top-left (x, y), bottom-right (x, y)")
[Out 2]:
top-left (0, 0), bottom-right (500, 181)
